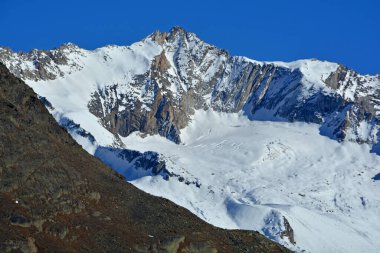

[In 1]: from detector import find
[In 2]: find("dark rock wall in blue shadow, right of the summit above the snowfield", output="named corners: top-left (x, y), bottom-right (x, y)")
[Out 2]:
top-left (240, 67), bottom-right (343, 124)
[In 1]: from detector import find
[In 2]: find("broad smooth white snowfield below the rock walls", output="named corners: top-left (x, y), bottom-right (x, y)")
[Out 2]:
top-left (117, 111), bottom-right (380, 252)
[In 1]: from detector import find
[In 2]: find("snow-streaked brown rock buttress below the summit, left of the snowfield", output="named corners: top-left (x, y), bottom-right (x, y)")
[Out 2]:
top-left (88, 81), bottom-right (189, 143)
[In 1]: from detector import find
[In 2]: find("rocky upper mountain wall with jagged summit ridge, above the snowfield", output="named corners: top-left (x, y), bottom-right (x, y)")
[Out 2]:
top-left (0, 27), bottom-right (380, 144)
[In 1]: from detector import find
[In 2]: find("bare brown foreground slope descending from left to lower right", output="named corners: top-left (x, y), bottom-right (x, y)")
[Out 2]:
top-left (0, 64), bottom-right (286, 252)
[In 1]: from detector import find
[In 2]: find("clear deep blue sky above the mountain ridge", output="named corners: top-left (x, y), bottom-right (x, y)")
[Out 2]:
top-left (0, 0), bottom-right (380, 74)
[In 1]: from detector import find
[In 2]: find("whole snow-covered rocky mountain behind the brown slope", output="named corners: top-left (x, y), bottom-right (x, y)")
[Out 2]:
top-left (0, 27), bottom-right (380, 252)
